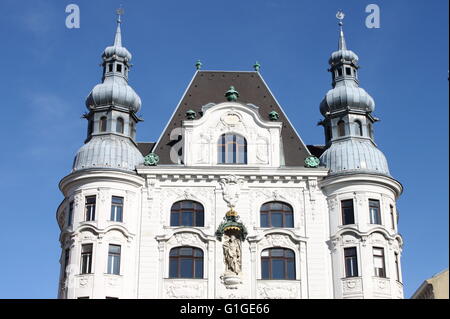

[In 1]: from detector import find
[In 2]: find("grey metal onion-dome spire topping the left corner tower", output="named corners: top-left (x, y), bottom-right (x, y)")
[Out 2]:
top-left (73, 15), bottom-right (144, 171)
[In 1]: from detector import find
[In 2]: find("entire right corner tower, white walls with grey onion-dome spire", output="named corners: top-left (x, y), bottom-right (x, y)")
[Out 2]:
top-left (319, 11), bottom-right (403, 298)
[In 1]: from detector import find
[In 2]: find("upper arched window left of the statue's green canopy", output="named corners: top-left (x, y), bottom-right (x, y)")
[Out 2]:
top-left (170, 200), bottom-right (205, 227)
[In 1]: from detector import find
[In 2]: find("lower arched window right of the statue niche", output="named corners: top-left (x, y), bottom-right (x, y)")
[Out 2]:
top-left (261, 248), bottom-right (295, 280)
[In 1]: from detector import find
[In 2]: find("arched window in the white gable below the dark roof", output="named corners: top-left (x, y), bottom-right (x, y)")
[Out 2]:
top-left (217, 134), bottom-right (247, 164)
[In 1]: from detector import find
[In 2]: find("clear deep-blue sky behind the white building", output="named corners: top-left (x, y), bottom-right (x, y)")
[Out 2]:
top-left (0, 0), bottom-right (449, 298)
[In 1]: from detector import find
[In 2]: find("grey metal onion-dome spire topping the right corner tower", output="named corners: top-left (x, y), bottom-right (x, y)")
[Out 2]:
top-left (320, 12), bottom-right (389, 175)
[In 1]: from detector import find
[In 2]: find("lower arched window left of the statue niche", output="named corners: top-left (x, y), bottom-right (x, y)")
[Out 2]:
top-left (169, 246), bottom-right (203, 278)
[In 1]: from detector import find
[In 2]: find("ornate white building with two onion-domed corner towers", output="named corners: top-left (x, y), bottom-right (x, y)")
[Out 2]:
top-left (56, 13), bottom-right (403, 299)
